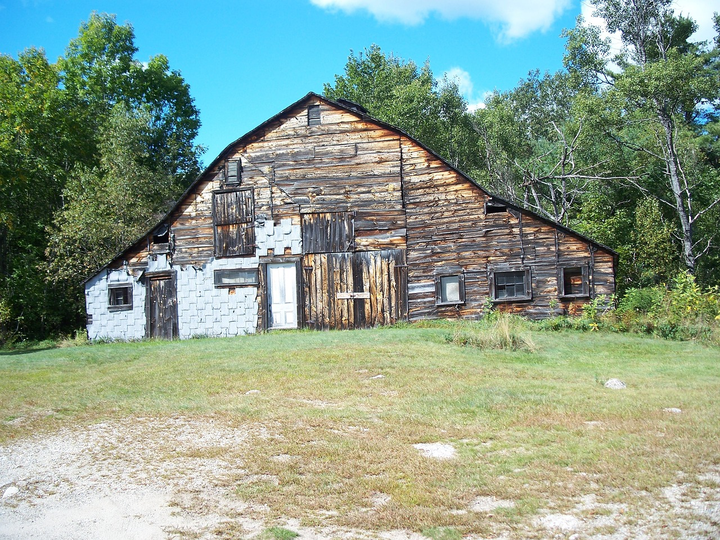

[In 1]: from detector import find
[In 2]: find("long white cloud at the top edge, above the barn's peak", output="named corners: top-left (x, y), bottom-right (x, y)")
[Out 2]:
top-left (310, 0), bottom-right (572, 40)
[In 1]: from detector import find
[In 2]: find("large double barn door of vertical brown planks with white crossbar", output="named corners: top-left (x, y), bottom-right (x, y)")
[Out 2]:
top-left (304, 249), bottom-right (407, 330)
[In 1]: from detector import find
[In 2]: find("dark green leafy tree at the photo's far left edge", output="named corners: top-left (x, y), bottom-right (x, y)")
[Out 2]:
top-left (0, 49), bottom-right (84, 342)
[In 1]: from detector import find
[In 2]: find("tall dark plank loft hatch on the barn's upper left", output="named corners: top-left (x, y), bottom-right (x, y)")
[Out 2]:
top-left (213, 189), bottom-right (255, 257)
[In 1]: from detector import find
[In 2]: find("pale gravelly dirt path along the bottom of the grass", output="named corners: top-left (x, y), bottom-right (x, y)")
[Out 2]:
top-left (0, 417), bottom-right (720, 540)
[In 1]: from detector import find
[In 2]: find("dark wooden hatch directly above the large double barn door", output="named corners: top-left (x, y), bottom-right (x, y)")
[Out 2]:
top-left (302, 212), bottom-right (355, 253)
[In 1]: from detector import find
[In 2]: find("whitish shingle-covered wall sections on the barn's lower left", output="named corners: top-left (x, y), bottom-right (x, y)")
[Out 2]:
top-left (85, 219), bottom-right (302, 340)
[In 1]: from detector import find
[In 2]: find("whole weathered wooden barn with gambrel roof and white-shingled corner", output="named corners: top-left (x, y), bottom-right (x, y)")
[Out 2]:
top-left (85, 93), bottom-right (616, 339)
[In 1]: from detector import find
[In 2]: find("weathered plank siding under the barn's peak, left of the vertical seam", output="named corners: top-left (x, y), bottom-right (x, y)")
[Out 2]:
top-left (118, 99), bottom-right (406, 267)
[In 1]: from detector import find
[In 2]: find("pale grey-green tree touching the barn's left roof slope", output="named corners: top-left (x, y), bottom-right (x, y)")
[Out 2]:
top-left (47, 103), bottom-right (182, 288)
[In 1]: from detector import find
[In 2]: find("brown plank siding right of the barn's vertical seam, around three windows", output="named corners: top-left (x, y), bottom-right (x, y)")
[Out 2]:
top-left (402, 139), bottom-right (614, 320)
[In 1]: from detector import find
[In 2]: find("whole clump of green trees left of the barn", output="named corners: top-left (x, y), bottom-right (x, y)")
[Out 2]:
top-left (0, 13), bottom-right (201, 341)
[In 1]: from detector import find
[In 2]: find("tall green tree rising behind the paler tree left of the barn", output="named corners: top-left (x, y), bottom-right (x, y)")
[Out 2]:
top-left (59, 13), bottom-right (202, 184)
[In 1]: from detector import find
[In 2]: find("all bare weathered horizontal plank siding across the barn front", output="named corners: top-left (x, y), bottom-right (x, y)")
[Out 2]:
top-left (101, 99), bottom-right (614, 326)
